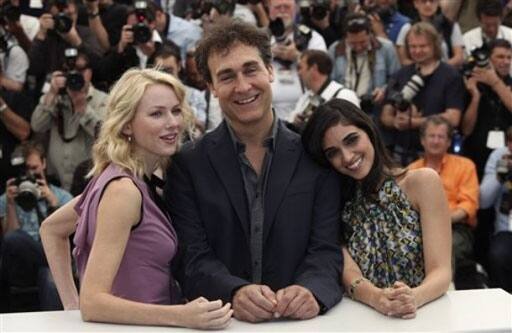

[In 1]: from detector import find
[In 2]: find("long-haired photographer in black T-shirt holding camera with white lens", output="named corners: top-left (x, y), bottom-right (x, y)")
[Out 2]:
top-left (380, 22), bottom-right (464, 166)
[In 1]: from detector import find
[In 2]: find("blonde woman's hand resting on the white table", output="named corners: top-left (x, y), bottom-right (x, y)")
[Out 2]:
top-left (179, 297), bottom-right (233, 329)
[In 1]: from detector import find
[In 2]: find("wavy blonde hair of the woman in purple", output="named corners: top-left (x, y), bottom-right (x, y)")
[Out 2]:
top-left (88, 69), bottom-right (194, 177)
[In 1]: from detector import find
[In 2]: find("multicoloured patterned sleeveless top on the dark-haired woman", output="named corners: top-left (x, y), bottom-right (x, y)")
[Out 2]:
top-left (342, 178), bottom-right (425, 288)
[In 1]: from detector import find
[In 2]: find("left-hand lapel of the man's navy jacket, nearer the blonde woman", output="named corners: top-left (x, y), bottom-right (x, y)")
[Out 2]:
top-left (207, 122), bottom-right (250, 239)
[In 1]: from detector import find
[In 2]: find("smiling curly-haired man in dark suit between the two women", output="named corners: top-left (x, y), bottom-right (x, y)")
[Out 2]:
top-left (165, 20), bottom-right (343, 322)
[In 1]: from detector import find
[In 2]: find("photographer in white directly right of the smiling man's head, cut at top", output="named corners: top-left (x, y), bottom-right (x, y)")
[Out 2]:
top-left (268, 0), bottom-right (327, 119)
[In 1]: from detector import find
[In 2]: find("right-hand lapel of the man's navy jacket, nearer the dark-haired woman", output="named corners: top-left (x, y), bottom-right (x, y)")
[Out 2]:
top-left (263, 122), bottom-right (302, 244)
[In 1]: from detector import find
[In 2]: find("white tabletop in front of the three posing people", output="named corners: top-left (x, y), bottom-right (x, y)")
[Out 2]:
top-left (0, 289), bottom-right (512, 333)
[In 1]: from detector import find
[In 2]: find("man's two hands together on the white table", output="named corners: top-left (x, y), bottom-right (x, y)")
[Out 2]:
top-left (233, 284), bottom-right (320, 323)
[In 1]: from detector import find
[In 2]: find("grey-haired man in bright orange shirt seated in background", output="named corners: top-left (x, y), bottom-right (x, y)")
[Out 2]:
top-left (409, 115), bottom-right (481, 289)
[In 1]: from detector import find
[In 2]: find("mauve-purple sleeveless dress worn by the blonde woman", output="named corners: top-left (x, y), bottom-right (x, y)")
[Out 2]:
top-left (73, 164), bottom-right (178, 304)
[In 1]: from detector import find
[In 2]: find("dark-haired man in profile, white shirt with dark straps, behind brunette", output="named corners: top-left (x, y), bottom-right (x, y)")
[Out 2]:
top-left (288, 50), bottom-right (359, 133)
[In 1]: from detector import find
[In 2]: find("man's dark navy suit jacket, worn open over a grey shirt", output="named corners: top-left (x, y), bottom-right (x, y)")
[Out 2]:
top-left (165, 122), bottom-right (343, 310)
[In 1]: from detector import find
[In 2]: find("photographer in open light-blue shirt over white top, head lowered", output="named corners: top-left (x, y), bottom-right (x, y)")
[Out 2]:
top-left (329, 13), bottom-right (400, 114)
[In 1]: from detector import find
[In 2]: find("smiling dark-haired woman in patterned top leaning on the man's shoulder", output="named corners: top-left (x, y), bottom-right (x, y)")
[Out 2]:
top-left (302, 99), bottom-right (451, 318)
